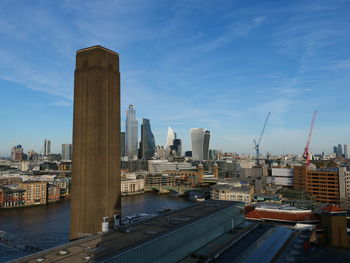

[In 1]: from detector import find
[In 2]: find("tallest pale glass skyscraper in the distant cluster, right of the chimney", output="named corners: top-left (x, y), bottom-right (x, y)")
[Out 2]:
top-left (125, 105), bottom-right (138, 160)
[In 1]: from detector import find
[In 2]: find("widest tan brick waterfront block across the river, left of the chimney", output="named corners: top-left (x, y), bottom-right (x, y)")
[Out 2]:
top-left (18, 182), bottom-right (47, 205)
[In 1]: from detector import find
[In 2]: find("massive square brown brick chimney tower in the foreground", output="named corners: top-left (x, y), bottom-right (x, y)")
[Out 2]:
top-left (70, 46), bottom-right (121, 239)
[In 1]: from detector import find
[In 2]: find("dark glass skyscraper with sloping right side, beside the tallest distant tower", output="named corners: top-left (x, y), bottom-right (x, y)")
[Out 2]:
top-left (141, 119), bottom-right (156, 160)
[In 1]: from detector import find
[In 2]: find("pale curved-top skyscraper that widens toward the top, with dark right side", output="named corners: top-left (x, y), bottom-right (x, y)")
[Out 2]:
top-left (191, 128), bottom-right (210, 161)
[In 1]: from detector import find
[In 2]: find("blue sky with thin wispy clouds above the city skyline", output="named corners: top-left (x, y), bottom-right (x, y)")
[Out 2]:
top-left (0, 0), bottom-right (350, 156)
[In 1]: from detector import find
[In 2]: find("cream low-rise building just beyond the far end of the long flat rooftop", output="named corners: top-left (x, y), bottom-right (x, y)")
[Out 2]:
top-left (210, 184), bottom-right (254, 204)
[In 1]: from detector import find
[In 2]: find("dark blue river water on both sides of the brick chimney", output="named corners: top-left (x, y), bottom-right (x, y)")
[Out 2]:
top-left (0, 192), bottom-right (192, 262)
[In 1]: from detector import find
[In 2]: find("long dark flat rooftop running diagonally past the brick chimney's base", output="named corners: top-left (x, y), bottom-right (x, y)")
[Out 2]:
top-left (11, 200), bottom-right (242, 263)
